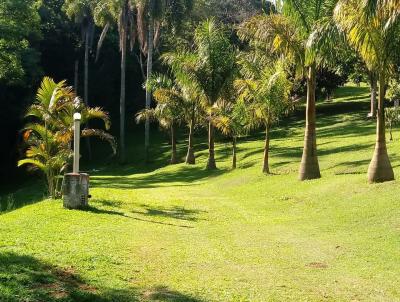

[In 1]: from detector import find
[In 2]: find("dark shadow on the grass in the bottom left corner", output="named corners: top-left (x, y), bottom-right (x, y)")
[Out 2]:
top-left (0, 252), bottom-right (204, 302)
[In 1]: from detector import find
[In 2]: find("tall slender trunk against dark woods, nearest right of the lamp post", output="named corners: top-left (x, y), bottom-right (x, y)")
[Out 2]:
top-left (119, 24), bottom-right (127, 164)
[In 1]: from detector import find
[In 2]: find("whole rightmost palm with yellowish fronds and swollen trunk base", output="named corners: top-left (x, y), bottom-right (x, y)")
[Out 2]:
top-left (335, 0), bottom-right (400, 182)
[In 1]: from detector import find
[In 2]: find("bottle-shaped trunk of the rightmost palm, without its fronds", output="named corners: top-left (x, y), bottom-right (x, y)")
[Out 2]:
top-left (368, 74), bottom-right (394, 183)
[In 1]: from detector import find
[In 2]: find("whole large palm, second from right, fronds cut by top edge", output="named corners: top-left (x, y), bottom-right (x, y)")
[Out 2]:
top-left (241, 0), bottom-right (337, 180)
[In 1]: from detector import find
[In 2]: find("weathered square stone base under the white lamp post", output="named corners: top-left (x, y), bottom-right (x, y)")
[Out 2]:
top-left (63, 173), bottom-right (89, 209)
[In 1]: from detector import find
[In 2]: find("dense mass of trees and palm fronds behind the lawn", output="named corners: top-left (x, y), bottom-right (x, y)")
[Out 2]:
top-left (0, 0), bottom-right (400, 189)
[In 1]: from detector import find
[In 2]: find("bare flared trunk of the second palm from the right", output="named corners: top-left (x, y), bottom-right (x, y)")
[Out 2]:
top-left (299, 65), bottom-right (321, 181)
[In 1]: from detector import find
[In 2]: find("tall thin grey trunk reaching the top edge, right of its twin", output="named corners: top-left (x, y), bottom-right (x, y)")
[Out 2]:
top-left (144, 5), bottom-right (154, 161)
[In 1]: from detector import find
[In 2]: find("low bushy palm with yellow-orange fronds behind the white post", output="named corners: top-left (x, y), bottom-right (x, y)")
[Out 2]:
top-left (18, 77), bottom-right (116, 198)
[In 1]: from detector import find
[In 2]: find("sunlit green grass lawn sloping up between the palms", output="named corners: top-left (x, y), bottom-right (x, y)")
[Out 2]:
top-left (0, 87), bottom-right (400, 301)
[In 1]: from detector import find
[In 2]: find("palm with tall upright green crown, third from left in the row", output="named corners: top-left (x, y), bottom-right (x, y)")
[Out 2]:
top-left (164, 20), bottom-right (236, 169)
